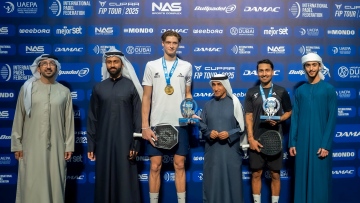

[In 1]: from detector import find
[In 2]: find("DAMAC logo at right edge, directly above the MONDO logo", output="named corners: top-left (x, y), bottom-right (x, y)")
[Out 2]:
top-left (334, 124), bottom-right (360, 142)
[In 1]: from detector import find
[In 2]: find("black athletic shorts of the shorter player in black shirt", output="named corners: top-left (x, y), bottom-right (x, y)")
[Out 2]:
top-left (249, 149), bottom-right (283, 171)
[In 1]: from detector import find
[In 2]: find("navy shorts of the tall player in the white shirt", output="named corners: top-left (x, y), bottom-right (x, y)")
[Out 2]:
top-left (145, 126), bottom-right (190, 156)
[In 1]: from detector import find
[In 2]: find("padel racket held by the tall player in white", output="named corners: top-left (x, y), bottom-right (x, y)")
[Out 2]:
top-left (133, 123), bottom-right (179, 149)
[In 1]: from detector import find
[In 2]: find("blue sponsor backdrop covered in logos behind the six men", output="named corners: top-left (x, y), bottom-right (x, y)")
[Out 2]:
top-left (0, 0), bottom-right (360, 203)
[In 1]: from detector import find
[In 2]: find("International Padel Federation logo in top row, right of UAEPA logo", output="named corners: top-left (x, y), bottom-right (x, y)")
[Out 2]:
top-left (48, 0), bottom-right (92, 17)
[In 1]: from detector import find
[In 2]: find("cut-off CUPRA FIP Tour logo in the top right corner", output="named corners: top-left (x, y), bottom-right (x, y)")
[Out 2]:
top-left (334, 2), bottom-right (360, 20)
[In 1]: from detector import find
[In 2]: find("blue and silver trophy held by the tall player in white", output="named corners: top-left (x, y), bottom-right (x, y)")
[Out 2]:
top-left (179, 98), bottom-right (199, 126)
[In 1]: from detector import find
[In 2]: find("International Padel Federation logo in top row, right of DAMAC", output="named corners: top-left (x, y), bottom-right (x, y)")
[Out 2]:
top-left (289, 2), bottom-right (330, 19)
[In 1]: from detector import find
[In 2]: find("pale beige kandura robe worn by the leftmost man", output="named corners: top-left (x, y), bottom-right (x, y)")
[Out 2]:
top-left (11, 80), bottom-right (74, 203)
